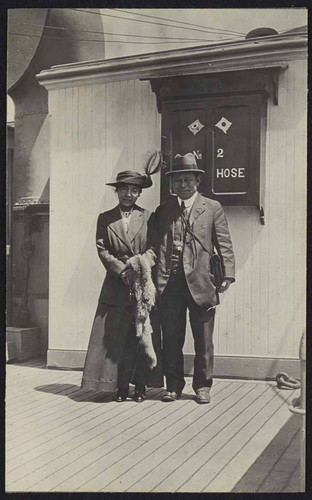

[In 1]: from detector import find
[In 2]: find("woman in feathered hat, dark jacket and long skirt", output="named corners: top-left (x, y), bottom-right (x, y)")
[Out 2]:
top-left (82, 166), bottom-right (163, 402)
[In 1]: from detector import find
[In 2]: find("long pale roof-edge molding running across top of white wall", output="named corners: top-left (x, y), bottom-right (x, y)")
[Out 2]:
top-left (37, 33), bottom-right (307, 90)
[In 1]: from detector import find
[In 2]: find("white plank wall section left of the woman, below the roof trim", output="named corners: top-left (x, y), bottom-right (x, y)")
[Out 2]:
top-left (49, 81), bottom-right (160, 350)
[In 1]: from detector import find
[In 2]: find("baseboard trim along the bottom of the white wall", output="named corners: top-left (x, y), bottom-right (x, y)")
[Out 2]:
top-left (47, 349), bottom-right (300, 380)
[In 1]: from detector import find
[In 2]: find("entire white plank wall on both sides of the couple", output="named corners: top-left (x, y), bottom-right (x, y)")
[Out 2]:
top-left (49, 60), bottom-right (306, 364)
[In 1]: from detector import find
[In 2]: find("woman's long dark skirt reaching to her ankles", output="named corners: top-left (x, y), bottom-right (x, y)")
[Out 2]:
top-left (82, 302), bottom-right (163, 392)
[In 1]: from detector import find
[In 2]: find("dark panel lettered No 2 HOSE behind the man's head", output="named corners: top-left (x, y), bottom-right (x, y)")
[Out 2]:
top-left (161, 94), bottom-right (262, 205)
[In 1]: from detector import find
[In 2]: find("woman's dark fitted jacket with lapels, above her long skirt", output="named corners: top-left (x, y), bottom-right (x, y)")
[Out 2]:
top-left (96, 205), bottom-right (153, 306)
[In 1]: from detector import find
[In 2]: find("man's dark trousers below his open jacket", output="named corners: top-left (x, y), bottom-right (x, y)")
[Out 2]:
top-left (160, 269), bottom-right (215, 395)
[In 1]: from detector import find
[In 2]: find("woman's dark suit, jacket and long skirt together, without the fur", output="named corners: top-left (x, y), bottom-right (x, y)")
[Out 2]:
top-left (82, 205), bottom-right (163, 392)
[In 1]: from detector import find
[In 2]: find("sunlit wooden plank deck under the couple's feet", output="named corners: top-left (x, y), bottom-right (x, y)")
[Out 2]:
top-left (6, 362), bottom-right (300, 492)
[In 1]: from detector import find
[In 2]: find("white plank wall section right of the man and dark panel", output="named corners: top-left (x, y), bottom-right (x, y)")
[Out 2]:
top-left (185, 60), bottom-right (307, 358)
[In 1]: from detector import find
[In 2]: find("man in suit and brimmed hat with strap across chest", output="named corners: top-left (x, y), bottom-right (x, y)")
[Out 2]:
top-left (149, 153), bottom-right (235, 403)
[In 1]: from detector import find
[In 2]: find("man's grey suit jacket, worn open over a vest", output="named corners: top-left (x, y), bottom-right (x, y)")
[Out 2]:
top-left (148, 193), bottom-right (235, 309)
